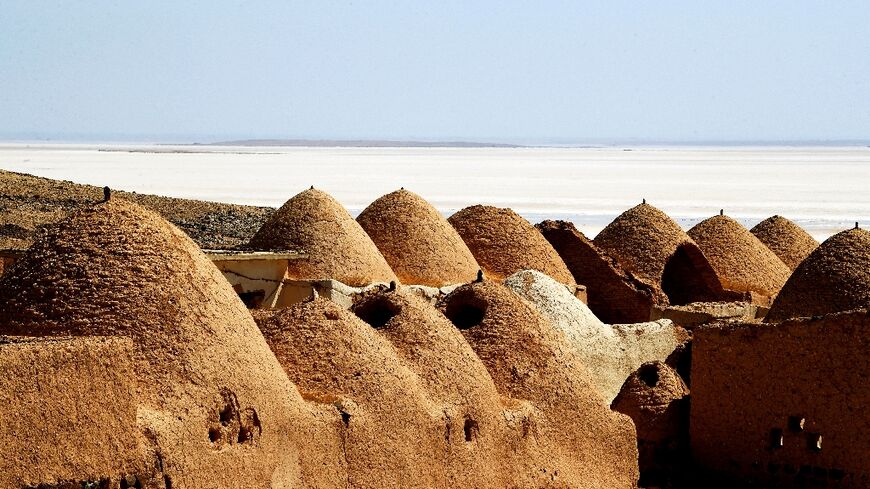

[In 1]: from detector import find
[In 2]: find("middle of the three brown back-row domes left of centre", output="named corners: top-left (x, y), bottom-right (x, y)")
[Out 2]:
top-left (357, 189), bottom-right (480, 287)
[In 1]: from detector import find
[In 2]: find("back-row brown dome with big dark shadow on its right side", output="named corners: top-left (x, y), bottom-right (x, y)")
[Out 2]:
top-left (594, 204), bottom-right (727, 305)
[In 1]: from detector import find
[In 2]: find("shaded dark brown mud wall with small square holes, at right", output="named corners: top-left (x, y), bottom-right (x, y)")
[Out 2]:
top-left (690, 310), bottom-right (870, 488)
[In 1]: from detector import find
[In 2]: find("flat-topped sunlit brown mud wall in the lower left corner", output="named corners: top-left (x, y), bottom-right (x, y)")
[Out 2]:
top-left (0, 337), bottom-right (146, 487)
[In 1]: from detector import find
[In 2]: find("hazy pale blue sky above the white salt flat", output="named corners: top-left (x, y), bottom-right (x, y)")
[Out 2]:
top-left (0, 0), bottom-right (870, 142)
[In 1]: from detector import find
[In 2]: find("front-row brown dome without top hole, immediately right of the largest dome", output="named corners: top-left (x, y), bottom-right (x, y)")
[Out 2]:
top-left (257, 299), bottom-right (448, 488)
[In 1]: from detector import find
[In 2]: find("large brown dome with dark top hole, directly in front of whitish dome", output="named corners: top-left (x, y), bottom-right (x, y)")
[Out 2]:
top-left (439, 282), bottom-right (638, 488)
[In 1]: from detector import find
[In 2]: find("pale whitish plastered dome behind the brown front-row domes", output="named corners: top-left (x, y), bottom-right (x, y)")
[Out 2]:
top-left (504, 270), bottom-right (686, 404)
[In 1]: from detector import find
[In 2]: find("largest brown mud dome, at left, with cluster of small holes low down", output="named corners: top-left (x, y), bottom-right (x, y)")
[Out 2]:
top-left (0, 199), bottom-right (334, 488)
